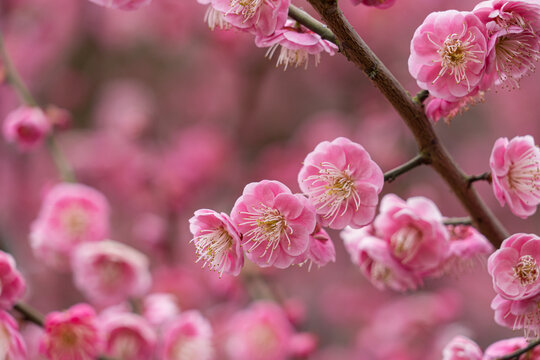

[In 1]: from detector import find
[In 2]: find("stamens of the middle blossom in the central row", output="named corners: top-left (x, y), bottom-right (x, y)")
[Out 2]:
top-left (242, 204), bottom-right (293, 259)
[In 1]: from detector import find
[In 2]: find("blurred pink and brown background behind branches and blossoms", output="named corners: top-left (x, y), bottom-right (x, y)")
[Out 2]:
top-left (0, 0), bottom-right (540, 360)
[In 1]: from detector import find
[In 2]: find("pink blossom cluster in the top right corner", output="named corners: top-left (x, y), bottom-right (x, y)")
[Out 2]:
top-left (409, 0), bottom-right (540, 121)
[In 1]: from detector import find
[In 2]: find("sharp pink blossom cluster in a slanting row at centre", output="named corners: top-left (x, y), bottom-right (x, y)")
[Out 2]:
top-left (190, 138), bottom-right (384, 275)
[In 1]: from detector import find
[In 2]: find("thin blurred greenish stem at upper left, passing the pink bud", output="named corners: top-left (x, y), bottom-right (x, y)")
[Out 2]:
top-left (0, 31), bottom-right (75, 182)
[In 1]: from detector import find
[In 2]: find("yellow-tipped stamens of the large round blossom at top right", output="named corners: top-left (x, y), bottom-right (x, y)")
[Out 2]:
top-left (428, 25), bottom-right (482, 91)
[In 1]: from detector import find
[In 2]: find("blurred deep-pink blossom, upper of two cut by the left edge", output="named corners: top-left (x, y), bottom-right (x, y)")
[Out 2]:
top-left (0, 251), bottom-right (26, 310)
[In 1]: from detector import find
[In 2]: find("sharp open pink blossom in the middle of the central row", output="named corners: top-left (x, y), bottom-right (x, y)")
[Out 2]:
top-left (231, 180), bottom-right (316, 268)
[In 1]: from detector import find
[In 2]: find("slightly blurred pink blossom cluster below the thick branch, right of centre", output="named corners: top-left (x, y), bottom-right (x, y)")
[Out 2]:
top-left (341, 194), bottom-right (493, 291)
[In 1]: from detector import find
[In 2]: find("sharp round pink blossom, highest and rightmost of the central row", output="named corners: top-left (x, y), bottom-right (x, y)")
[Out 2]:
top-left (298, 137), bottom-right (384, 229)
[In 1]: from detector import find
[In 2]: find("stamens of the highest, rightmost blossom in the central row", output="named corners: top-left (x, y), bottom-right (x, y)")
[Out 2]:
top-left (305, 162), bottom-right (360, 221)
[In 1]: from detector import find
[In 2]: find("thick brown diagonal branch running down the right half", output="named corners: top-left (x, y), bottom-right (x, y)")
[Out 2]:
top-left (308, 0), bottom-right (508, 247)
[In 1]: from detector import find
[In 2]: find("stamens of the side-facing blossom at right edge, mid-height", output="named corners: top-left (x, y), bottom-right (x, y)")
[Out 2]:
top-left (508, 147), bottom-right (540, 199)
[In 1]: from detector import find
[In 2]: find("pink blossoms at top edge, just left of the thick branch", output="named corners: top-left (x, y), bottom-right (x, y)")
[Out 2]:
top-left (198, 0), bottom-right (337, 69)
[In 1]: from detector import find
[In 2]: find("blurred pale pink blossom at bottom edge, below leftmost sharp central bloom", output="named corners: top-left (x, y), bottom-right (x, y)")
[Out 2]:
top-left (159, 310), bottom-right (214, 360)
